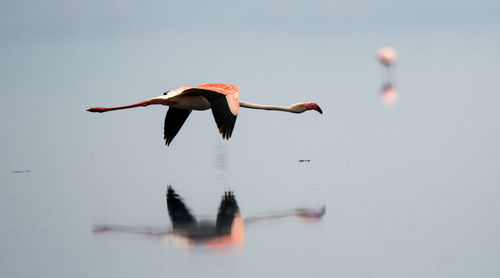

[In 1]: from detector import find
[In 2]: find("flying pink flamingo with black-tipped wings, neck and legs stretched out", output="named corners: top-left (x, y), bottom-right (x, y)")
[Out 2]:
top-left (87, 83), bottom-right (323, 146)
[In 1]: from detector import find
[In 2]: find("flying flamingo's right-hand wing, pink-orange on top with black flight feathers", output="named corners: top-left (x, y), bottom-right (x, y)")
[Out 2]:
top-left (184, 88), bottom-right (239, 139)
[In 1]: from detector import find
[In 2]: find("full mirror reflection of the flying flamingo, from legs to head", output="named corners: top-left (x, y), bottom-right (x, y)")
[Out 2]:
top-left (93, 186), bottom-right (326, 247)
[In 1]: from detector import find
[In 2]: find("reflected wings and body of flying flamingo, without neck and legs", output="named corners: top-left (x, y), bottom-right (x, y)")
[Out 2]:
top-left (167, 186), bottom-right (245, 245)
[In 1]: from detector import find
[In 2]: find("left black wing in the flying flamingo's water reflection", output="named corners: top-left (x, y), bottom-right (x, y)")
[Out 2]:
top-left (167, 186), bottom-right (196, 229)
